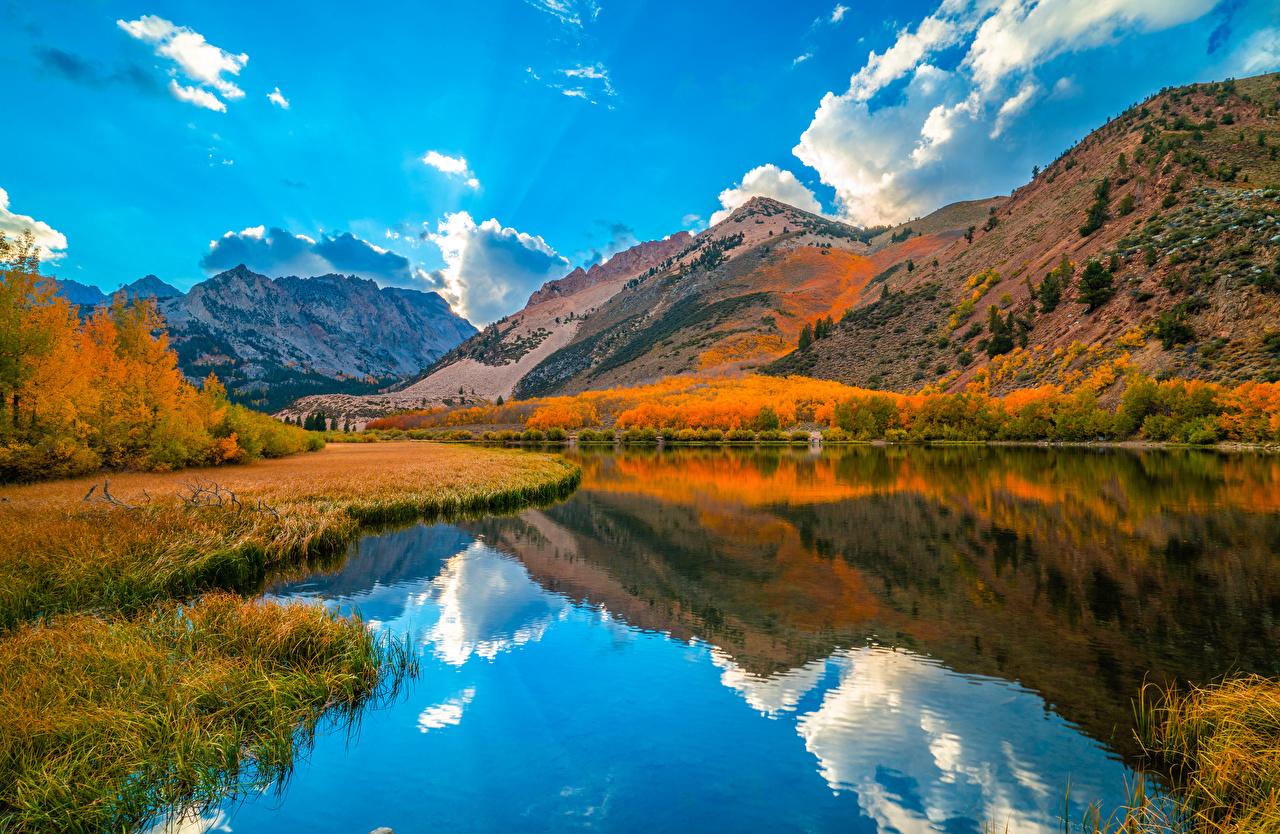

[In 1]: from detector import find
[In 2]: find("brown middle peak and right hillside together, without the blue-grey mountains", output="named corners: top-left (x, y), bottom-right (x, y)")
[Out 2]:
top-left (384, 74), bottom-right (1280, 409)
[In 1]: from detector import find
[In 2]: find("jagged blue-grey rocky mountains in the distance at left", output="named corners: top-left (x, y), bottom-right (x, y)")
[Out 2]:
top-left (60, 265), bottom-right (476, 411)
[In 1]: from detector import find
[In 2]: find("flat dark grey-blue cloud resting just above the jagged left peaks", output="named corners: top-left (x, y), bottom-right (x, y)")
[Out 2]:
top-left (200, 225), bottom-right (424, 289)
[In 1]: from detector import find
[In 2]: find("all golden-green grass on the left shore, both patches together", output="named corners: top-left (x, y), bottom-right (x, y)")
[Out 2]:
top-left (0, 443), bottom-right (579, 834)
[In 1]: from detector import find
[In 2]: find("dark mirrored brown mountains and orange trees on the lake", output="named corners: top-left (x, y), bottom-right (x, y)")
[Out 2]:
top-left (463, 448), bottom-right (1280, 753)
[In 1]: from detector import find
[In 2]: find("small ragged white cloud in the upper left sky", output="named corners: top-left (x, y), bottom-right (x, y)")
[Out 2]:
top-left (115, 14), bottom-right (248, 113)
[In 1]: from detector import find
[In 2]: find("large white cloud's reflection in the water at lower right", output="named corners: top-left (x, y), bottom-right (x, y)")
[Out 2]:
top-left (796, 649), bottom-right (1125, 834)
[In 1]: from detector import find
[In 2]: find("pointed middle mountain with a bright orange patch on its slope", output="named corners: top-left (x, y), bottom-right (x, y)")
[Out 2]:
top-left (504, 197), bottom-right (960, 398)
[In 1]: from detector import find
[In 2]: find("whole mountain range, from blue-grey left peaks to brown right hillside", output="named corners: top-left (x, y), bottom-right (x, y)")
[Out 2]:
top-left (64, 74), bottom-right (1280, 423)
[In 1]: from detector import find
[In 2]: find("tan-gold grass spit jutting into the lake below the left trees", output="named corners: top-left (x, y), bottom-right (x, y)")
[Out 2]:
top-left (0, 443), bottom-right (579, 629)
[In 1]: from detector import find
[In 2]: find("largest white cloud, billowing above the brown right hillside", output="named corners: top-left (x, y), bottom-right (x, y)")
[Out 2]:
top-left (794, 0), bottom-right (1223, 225)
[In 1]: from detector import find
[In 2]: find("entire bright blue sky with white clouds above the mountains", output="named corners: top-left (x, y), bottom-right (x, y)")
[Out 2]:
top-left (0, 0), bottom-right (1280, 325)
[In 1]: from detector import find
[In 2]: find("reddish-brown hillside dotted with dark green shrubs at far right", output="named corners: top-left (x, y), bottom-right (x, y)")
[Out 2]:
top-left (765, 74), bottom-right (1280, 393)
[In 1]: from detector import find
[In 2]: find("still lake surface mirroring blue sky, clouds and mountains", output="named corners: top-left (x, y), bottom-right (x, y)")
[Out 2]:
top-left (205, 448), bottom-right (1280, 834)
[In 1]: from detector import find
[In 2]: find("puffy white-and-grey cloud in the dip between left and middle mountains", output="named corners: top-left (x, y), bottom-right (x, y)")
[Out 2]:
top-left (422, 211), bottom-right (570, 325)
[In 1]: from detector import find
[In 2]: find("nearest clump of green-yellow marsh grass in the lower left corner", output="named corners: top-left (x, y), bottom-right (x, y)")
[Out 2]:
top-left (0, 594), bottom-right (413, 834)
